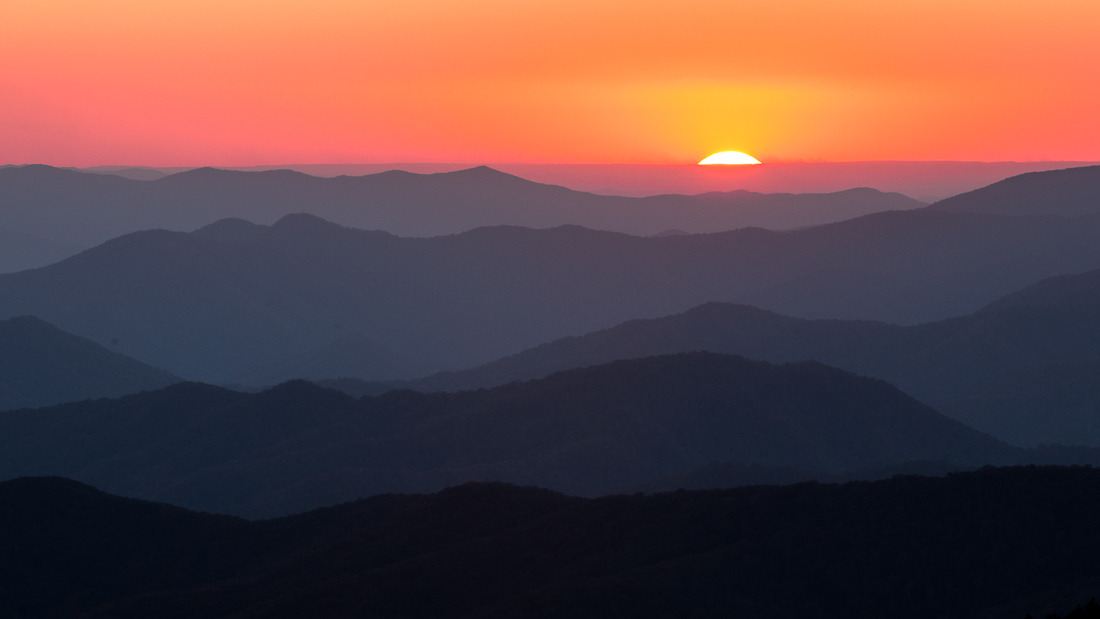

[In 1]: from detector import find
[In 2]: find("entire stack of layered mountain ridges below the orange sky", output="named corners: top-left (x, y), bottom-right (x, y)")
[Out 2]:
top-left (0, 161), bottom-right (1100, 619)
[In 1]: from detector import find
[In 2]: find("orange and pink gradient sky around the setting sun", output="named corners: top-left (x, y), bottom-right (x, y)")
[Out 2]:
top-left (0, 0), bottom-right (1100, 166)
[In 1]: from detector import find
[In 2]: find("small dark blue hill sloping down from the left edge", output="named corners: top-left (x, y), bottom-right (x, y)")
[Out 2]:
top-left (0, 316), bottom-right (179, 410)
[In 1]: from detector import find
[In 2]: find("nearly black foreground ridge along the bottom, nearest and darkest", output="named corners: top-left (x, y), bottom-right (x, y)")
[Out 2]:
top-left (0, 467), bottom-right (1100, 619)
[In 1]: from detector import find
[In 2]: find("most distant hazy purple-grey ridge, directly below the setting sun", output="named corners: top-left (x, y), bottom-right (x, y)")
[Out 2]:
top-left (0, 165), bottom-right (923, 273)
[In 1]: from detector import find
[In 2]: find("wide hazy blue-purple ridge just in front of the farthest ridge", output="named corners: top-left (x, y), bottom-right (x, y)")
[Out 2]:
top-left (0, 197), bottom-right (1100, 383)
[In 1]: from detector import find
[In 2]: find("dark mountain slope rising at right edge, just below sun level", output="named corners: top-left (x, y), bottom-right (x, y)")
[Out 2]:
top-left (928, 166), bottom-right (1100, 217)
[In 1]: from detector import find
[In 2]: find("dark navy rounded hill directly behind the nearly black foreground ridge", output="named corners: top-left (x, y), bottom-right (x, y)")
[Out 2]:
top-left (0, 353), bottom-right (1024, 516)
